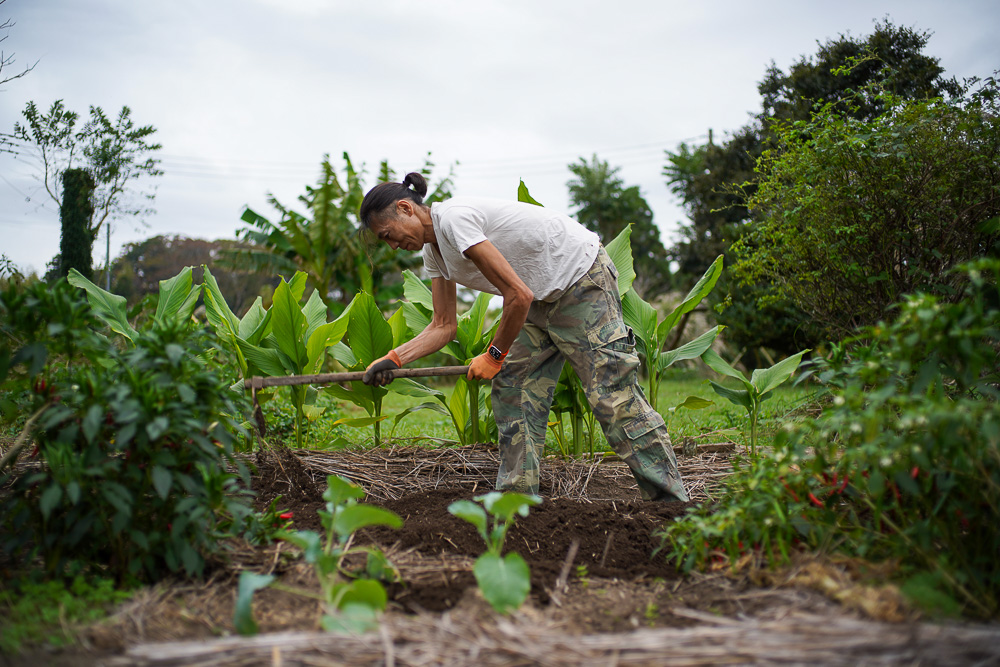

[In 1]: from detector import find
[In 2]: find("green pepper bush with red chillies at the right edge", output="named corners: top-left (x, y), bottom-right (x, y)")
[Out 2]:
top-left (663, 259), bottom-right (1000, 616)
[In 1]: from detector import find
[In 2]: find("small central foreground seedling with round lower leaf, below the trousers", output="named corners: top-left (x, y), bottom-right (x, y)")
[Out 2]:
top-left (448, 491), bottom-right (542, 614)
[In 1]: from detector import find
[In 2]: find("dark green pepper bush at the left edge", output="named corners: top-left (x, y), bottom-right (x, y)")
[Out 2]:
top-left (0, 282), bottom-right (251, 578)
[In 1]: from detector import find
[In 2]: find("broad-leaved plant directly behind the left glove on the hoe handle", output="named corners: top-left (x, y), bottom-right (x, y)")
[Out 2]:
top-left (323, 292), bottom-right (408, 447)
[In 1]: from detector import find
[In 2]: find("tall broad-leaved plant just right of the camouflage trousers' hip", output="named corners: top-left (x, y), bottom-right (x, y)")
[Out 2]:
top-left (622, 255), bottom-right (724, 410)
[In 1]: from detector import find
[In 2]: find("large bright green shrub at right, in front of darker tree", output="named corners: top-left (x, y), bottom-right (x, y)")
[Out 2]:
top-left (733, 79), bottom-right (1000, 338)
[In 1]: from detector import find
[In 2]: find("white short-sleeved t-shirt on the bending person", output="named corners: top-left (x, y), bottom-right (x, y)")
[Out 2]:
top-left (423, 197), bottom-right (601, 301)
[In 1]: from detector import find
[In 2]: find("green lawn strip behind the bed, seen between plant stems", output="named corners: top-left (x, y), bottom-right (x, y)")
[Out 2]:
top-left (252, 369), bottom-right (816, 453)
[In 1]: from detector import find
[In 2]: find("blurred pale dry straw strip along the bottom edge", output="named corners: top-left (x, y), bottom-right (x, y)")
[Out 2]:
top-left (106, 610), bottom-right (1000, 667)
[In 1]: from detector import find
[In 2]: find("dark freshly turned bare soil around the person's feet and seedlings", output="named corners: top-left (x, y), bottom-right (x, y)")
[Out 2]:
top-left (253, 450), bottom-right (689, 611)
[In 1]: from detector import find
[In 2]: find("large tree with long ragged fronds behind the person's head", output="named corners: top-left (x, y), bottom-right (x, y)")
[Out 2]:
top-left (223, 153), bottom-right (451, 309)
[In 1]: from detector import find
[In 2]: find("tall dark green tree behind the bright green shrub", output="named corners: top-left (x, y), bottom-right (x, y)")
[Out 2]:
top-left (663, 20), bottom-right (959, 354)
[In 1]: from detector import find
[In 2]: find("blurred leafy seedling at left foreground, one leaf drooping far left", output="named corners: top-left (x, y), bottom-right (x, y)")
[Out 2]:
top-left (233, 475), bottom-right (403, 635)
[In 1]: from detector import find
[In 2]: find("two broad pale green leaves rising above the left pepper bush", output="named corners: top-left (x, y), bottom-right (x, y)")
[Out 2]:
top-left (67, 266), bottom-right (201, 343)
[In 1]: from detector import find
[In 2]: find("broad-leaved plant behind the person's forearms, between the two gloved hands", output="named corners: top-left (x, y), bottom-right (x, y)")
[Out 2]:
top-left (389, 271), bottom-right (500, 445)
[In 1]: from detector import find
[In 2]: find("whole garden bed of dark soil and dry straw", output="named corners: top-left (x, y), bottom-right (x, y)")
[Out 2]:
top-left (7, 445), bottom-right (1000, 665)
